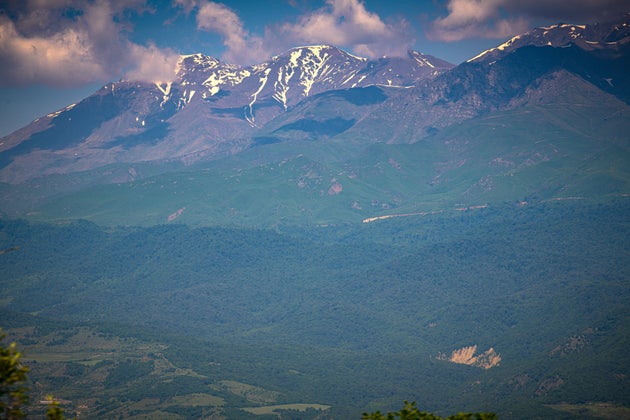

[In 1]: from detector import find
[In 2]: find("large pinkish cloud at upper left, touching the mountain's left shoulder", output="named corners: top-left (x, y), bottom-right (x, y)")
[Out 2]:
top-left (0, 0), bottom-right (176, 86)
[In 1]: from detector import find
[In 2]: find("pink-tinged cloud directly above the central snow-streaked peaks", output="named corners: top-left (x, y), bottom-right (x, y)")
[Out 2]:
top-left (184, 0), bottom-right (414, 64)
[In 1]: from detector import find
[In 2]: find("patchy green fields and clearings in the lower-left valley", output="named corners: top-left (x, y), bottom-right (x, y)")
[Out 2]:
top-left (1, 327), bottom-right (304, 419)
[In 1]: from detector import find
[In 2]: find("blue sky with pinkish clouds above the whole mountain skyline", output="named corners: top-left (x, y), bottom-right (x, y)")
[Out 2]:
top-left (0, 0), bottom-right (630, 135)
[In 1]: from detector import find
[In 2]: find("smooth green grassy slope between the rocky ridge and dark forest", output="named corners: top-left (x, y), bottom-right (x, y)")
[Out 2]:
top-left (27, 77), bottom-right (630, 226)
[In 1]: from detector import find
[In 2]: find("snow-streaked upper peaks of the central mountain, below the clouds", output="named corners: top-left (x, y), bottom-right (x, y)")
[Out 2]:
top-left (170, 45), bottom-right (452, 121)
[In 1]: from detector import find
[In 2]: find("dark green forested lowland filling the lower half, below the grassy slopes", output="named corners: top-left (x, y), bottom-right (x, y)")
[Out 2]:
top-left (0, 198), bottom-right (630, 419)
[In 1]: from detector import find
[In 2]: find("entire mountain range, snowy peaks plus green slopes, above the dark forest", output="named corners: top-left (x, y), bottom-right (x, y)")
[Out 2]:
top-left (0, 16), bottom-right (630, 223)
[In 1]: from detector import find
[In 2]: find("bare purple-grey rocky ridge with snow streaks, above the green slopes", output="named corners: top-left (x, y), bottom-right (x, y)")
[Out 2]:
top-left (0, 16), bottom-right (630, 184)
